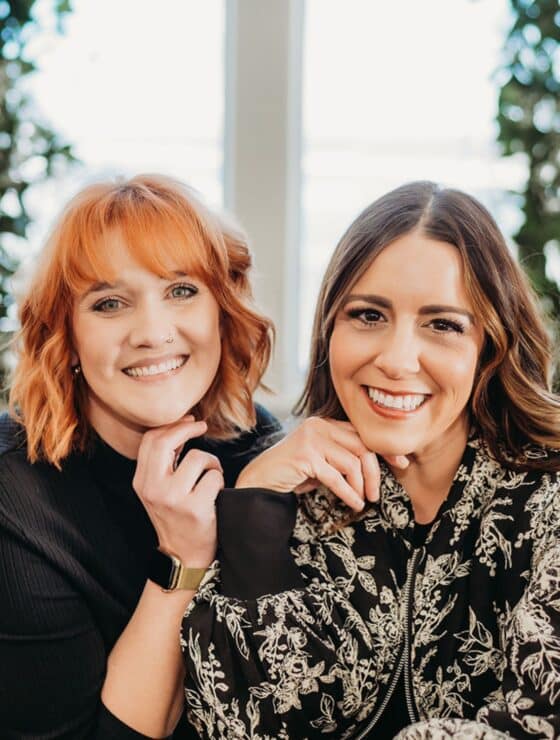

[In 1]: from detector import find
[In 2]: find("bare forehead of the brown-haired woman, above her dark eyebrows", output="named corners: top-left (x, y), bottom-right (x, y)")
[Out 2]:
top-left (350, 233), bottom-right (470, 307)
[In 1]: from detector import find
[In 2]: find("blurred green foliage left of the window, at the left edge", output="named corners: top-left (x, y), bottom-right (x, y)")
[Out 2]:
top-left (0, 0), bottom-right (74, 375)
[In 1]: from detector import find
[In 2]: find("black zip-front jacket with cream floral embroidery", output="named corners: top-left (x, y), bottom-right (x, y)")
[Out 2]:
top-left (181, 439), bottom-right (560, 740)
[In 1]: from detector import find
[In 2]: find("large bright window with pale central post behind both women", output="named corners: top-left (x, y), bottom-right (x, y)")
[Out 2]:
top-left (12, 0), bottom-right (526, 414)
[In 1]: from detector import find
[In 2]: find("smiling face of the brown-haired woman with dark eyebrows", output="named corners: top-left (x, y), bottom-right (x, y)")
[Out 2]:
top-left (329, 231), bottom-right (483, 458)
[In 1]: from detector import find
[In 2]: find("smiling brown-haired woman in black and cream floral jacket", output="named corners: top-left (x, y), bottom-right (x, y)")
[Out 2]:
top-left (182, 182), bottom-right (560, 740)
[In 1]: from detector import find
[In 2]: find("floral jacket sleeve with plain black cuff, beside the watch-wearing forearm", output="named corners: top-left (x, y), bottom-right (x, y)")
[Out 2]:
top-left (181, 489), bottom-right (376, 740)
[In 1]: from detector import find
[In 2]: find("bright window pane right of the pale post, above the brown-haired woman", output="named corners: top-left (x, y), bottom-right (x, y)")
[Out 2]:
top-left (299, 0), bottom-right (525, 368)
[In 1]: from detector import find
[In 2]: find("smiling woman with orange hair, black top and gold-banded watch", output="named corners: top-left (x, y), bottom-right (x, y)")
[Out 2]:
top-left (0, 176), bottom-right (278, 740)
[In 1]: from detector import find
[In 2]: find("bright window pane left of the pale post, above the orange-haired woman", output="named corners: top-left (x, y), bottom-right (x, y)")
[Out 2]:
top-left (22, 0), bottom-right (225, 251)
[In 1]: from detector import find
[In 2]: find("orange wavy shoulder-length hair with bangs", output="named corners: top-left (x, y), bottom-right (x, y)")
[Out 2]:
top-left (9, 175), bottom-right (273, 466)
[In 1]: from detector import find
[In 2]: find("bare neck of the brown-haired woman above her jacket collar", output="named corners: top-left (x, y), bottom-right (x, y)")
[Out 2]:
top-left (391, 420), bottom-right (468, 524)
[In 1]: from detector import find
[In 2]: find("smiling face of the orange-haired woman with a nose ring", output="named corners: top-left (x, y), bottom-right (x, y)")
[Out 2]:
top-left (72, 232), bottom-right (221, 457)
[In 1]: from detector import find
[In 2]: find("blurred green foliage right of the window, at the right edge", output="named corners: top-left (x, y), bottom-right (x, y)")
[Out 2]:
top-left (497, 0), bottom-right (560, 336)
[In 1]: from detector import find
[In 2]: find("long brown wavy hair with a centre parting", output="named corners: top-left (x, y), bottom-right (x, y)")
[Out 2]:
top-left (294, 182), bottom-right (560, 470)
